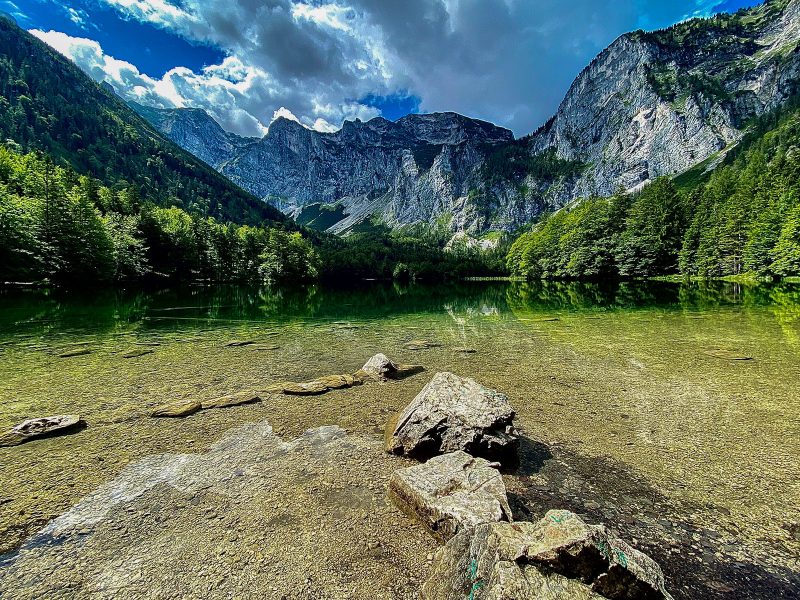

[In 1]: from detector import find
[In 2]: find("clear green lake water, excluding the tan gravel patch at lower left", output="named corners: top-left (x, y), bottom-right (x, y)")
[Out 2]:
top-left (0, 283), bottom-right (800, 597)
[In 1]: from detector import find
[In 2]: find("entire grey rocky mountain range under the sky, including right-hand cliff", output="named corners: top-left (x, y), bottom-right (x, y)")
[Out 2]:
top-left (134, 0), bottom-right (800, 233)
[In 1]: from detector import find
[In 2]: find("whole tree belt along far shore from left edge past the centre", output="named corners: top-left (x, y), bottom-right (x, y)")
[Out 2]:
top-left (0, 142), bottom-right (507, 285)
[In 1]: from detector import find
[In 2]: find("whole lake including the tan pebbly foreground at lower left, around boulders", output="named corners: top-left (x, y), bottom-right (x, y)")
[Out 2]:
top-left (0, 282), bottom-right (800, 598)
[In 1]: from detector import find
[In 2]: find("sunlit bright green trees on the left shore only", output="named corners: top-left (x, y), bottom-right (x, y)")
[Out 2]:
top-left (0, 147), bottom-right (320, 284)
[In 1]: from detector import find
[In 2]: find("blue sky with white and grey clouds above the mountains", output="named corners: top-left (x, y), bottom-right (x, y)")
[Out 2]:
top-left (7, 0), bottom-right (768, 135)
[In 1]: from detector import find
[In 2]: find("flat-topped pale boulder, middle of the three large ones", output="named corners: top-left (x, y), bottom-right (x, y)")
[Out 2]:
top-left (389, 451), bottom-right (511, 541)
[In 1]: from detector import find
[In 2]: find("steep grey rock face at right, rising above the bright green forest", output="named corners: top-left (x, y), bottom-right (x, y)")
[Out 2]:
top-left (528, 0), bottom-right (800, 203)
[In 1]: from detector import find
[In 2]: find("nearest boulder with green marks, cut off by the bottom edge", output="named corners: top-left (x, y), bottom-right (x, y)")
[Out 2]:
top-left (422, 511), bottom-right (671, 600)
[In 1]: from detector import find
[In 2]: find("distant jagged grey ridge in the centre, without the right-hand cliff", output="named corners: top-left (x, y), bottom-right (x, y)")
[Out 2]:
top-left (136, 107), bottom-right (513, 232)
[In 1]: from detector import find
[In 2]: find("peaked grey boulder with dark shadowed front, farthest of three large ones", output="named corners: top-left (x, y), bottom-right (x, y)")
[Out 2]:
top-left (386, 373), bottom-right (519, 465)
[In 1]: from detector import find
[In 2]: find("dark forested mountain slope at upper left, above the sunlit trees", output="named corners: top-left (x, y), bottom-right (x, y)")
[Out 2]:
top-left (0, 16), bottom-right (286, 224)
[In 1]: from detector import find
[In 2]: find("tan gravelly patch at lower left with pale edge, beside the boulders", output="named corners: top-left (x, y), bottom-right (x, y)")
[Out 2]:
top-left (0, 422), bottom-right (436, 600)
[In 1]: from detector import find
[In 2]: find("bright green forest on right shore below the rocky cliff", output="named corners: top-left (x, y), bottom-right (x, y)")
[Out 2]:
top-left (508, 99), bottom-right (800, 279)
